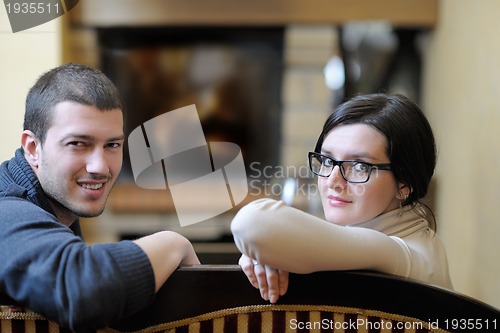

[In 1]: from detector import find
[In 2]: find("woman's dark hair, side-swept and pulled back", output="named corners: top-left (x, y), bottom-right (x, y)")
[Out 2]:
top-left (315, 94), bottom-right (436, 229)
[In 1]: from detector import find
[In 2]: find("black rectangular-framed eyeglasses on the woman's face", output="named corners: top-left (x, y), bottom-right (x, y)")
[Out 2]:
top-left (308, 152), bottom-right (391, 183)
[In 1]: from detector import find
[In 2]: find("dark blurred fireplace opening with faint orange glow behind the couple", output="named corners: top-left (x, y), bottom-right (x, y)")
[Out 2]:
top-left (97, 26), bottom-right (284, 182)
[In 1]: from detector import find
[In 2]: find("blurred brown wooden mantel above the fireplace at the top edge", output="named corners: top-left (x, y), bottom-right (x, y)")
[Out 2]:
top-left (71, 0), bottom-right (438, 28)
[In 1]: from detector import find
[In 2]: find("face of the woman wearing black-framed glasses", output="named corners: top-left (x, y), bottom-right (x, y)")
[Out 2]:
top-left (318, 124), bottom-right (401, 225)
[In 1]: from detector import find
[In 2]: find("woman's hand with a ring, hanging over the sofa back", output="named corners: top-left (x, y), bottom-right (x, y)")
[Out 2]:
top-left (238, 255), bottom-right (288, 303)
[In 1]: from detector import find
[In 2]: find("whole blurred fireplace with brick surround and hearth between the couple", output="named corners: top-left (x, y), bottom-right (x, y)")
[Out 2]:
top-left (75, 26), bottom-right (336, 252)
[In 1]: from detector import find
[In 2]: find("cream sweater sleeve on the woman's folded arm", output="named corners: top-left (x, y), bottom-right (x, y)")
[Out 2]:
top-left (231, 199), bottom-right (408, 275)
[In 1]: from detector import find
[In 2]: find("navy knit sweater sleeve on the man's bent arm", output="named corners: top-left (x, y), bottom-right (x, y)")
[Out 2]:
top-left (0, 198), bottom-right (155, 330)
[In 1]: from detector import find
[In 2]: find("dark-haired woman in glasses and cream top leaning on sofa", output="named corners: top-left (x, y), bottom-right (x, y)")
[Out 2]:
top-left (231, 94), bottom-right (452, 303)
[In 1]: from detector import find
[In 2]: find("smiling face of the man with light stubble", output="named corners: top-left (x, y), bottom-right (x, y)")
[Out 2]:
top-left (35, 102), bottom-right (124, 223)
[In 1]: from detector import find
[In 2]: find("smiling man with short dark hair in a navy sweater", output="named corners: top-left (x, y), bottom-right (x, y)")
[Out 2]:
top-left (0, 64), bottom-right (199, 330)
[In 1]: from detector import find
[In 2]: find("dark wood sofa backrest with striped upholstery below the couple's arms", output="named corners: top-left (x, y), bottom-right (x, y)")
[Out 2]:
top-left (0, 265), bottom-right (500, 333)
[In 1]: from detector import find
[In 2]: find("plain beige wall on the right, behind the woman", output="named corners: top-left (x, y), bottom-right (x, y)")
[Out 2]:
top-left (422, 0), bottom-right (500, 307)
